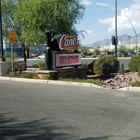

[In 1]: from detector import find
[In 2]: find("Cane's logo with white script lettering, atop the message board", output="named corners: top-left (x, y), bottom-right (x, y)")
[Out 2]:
top-left (53, 34), bottom-right (79, 51)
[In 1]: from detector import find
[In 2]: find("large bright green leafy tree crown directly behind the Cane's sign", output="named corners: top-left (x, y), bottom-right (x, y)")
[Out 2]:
top-left (14, 0), bottom-right (84, 45)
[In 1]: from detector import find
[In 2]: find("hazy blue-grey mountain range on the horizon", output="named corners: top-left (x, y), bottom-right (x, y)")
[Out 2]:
top-left (86, 33), bottom-right (140, 48)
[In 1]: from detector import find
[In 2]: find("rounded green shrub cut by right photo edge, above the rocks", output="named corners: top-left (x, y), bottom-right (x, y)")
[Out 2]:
top-left (128, 55), bottom-right (140, 72)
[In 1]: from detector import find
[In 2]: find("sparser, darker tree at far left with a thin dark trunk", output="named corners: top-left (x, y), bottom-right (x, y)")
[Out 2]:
top-left (2, 0), bottom-right (26, 65)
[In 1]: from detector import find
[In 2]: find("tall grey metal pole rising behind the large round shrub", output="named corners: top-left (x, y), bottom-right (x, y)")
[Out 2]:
top-left (115, 0), bottom-right (118, 59)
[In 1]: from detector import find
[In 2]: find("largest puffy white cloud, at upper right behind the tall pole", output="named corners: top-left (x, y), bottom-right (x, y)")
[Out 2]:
top-left (99, 0), bottom-right (140, 33)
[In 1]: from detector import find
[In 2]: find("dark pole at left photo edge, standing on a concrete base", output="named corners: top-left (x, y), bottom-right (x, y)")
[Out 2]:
top-left (0, 0), bottom-right (5, 61)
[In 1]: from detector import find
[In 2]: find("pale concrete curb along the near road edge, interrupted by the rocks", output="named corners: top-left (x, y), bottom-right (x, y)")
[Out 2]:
top-left (0, 77), bottom-right (140, 92)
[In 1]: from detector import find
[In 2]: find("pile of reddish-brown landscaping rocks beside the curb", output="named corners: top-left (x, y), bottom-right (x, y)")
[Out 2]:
top-left (102, 74), bottom-right (136, 89)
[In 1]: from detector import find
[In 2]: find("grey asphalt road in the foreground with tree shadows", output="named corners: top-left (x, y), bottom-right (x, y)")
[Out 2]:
top-left (0, 81), bottom-right (140, 140)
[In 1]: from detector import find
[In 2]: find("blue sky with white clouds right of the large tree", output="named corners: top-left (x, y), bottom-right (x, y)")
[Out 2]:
top-left (75, 0), bottom-right (140, 45)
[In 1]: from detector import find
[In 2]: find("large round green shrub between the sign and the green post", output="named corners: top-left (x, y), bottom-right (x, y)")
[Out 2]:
top-left (94, 55), bottom-right (119, 75)
